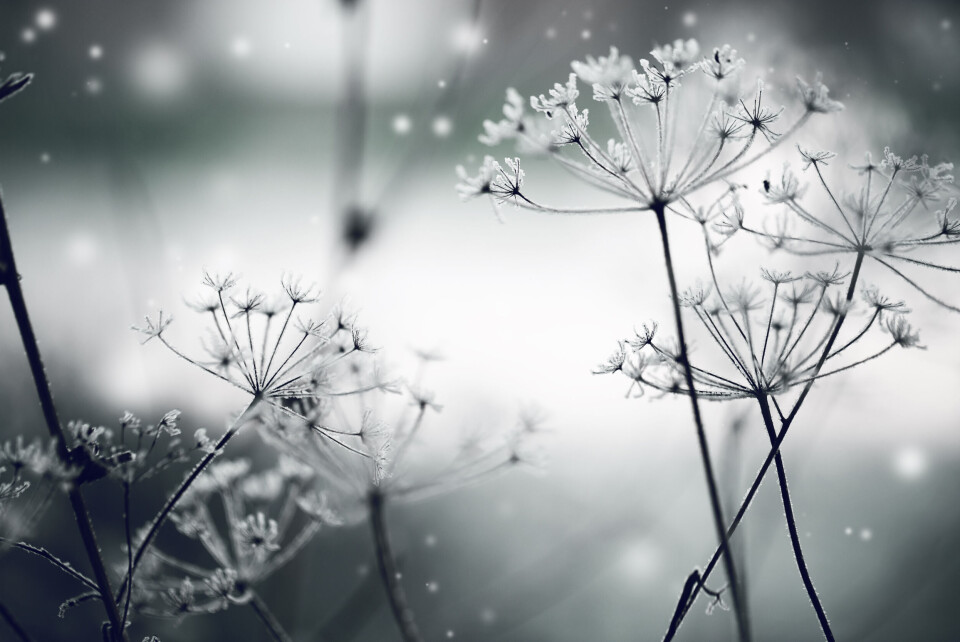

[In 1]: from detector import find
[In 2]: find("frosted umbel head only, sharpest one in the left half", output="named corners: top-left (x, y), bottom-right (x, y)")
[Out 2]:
top-left (134, 273), bottom-right (394, 452)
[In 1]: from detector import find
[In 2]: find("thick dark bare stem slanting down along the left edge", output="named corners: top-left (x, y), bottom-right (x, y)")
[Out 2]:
top-left (0, 200), bottom-right (127, 640)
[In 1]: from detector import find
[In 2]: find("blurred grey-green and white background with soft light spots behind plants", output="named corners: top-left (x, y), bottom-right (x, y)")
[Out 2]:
top-left (0, 0), bottom-right (960, 642)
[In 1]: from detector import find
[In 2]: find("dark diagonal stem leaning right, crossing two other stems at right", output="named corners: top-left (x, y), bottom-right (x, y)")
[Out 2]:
top-left (663, 252), bottom-right (864, 642)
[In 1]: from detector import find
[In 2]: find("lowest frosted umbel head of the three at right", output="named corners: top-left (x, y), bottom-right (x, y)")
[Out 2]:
top-left (595, 270), bottom-right (919, 400)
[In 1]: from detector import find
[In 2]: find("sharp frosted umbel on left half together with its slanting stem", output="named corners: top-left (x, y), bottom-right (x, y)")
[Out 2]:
top-left (118, 273), bottom-right (392, 624)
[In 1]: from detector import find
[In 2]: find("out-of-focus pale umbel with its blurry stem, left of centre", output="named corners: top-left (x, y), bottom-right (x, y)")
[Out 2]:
top-left (259, 352), bottom-right (541, 642)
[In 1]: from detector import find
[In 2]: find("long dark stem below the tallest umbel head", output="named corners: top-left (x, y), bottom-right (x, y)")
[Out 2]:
top-left (652, 204), bottom-right (750, 641)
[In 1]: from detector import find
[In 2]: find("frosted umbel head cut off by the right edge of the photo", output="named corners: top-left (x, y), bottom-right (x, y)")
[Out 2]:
top-left (718, 147), bottom-right (960, 311)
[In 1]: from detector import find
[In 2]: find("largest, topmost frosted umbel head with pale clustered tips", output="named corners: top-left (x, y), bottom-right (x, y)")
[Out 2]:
top-left (457, 40), bottom-right (843, 214)
